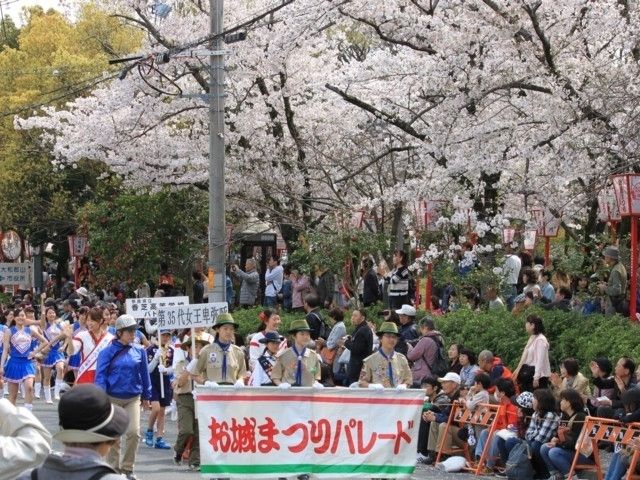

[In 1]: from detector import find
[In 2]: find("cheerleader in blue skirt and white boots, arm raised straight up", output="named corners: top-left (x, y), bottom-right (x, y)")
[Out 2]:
top-left (40, 302), bottom-right (65, 403)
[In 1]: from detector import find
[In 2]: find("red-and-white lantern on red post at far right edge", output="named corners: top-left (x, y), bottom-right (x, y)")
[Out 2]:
top-left (611, 173), bottom-right (640, 320)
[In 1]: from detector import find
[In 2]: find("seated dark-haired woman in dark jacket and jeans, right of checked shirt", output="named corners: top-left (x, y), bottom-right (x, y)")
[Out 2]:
top-left (540, 388), bottom-right (592, 480)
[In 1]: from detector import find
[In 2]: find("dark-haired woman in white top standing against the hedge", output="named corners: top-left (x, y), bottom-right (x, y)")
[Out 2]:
top-left (513, 315), bottom-right (551, 392)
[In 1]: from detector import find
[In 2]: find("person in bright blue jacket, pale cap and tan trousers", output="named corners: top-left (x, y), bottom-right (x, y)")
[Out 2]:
top-left (95, 315), bottom-right (151, 480)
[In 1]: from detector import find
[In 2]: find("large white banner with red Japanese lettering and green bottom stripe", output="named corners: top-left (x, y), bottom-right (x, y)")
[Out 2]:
top-left (196, 387), bottom-right (424, 479)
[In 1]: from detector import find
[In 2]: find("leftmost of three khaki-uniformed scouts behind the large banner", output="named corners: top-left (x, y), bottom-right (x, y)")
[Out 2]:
top-left (190, 313), bottom-right (247, 387)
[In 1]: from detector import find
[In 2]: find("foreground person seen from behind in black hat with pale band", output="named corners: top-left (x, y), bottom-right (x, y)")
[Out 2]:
top-left (18, 384), bottom-right (129, 480)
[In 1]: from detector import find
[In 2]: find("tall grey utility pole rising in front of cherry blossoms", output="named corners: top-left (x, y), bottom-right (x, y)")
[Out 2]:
top-left (208, 0), bottom-right (226, 302)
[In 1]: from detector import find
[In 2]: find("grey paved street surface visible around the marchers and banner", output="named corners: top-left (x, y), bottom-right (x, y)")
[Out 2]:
top-left (23, 400), bottom-right (488, 480)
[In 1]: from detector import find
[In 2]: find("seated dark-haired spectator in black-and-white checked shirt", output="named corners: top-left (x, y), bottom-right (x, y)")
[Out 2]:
top-left (524, 388), bottom-right (560, 478)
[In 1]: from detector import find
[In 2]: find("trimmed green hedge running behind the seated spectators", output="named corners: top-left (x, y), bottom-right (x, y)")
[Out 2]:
top-left (233, 307), bottom-right (640, 373)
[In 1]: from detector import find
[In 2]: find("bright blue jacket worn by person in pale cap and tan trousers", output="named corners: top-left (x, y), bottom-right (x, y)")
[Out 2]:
top-left (95, 340), bottom-right (151, 400)
